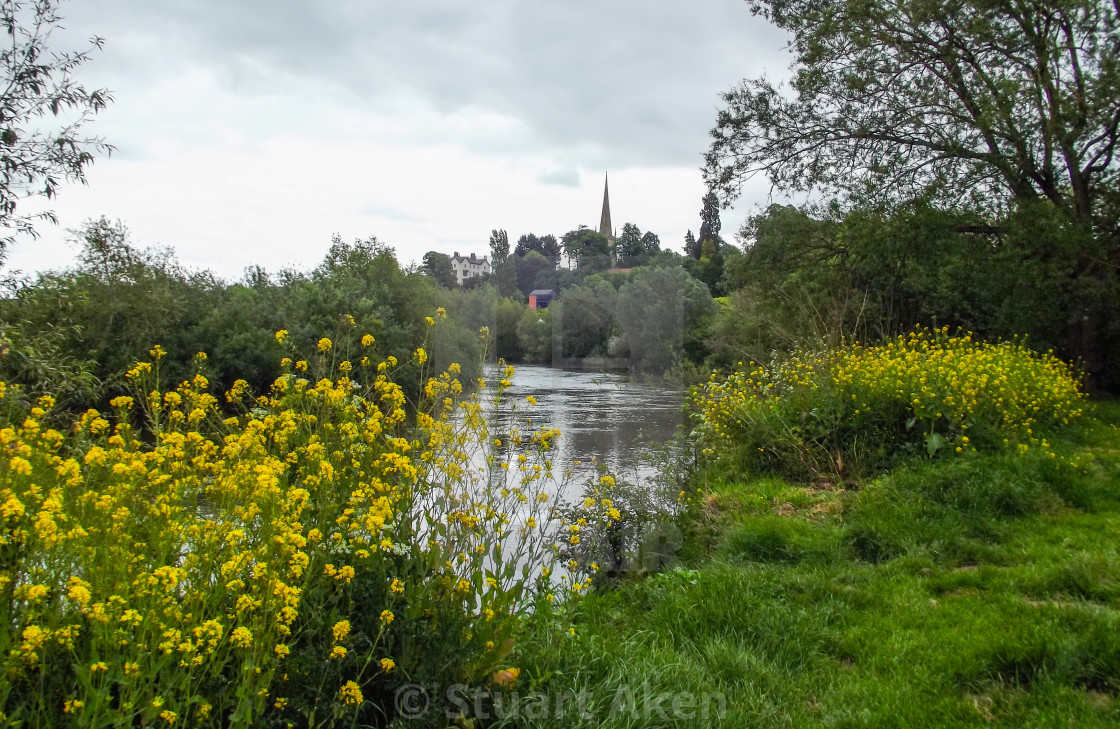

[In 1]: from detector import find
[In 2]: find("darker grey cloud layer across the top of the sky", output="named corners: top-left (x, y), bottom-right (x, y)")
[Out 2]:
top-left (54, 0), bottom-right (787, 170)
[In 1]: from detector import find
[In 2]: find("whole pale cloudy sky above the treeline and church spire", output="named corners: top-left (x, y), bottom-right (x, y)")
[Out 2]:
top-left (6, 0), bottom-right (788, 278)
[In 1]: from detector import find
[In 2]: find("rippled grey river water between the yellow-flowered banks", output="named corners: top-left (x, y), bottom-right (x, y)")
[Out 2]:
top-left (486, 365), bottom-right (684, 497)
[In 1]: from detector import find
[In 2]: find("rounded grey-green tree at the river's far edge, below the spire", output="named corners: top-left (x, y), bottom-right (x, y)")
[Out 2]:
top-left (617, 267), bottom-right (716, 372)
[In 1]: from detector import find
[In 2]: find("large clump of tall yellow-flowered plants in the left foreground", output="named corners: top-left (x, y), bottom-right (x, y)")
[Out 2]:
top-left (0, 321), bottom-right (578, 727)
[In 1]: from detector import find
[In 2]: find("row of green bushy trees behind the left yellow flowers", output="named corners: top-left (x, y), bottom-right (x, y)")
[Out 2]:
top-left (0, 219), bottom-right (480, 409)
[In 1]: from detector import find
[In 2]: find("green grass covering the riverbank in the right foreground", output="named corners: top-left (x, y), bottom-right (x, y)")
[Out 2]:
top-left (506, 402), bottom-right (1120, 728)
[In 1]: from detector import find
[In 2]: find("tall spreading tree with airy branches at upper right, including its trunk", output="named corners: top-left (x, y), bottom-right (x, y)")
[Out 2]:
top-left (704, 0), bottom-right (1120, 385)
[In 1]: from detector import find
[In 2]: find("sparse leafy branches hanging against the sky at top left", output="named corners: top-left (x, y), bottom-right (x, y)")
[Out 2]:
top-left (0, 0), bottom-right (113, 258)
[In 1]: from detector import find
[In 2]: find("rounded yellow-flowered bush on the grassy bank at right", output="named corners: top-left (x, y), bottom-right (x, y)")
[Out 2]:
top-left (691, 328), bottom-right (1084, 478)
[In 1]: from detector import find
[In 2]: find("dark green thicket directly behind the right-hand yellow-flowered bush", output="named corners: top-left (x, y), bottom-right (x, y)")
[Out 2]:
top-left (711, 199), bottom-right (1076, 371)
